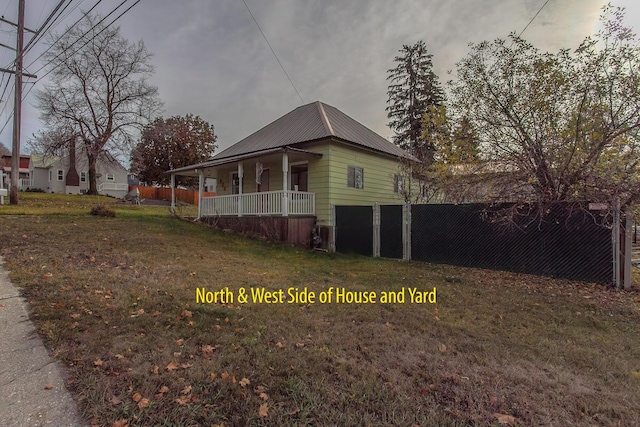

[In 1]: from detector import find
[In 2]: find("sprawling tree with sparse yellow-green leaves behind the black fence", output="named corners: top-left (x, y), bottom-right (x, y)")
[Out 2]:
top-left (450, 5), bottom-right (640, 221)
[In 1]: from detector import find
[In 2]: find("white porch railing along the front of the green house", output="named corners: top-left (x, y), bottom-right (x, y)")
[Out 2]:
top-left (201, 190), bottom-right (316, 216)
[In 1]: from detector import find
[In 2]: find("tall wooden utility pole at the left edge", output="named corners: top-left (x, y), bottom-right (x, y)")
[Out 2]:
top-left (9, 0), bottom-right (24, 205)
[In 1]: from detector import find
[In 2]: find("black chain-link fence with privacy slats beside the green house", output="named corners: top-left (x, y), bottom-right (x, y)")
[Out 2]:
top-left (335, 204), bottom-right (630, 287)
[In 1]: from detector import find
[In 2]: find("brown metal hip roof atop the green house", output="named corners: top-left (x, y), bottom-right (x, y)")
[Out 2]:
top-left (211, 101), bottom-right (412, 161)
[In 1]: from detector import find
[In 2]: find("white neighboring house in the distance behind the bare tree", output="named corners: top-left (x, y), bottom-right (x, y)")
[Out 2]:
top-left (29, 152), bottom-right (129, 198)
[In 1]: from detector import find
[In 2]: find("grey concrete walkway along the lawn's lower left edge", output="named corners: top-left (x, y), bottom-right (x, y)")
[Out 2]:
top-left (0, 257), bottom-right (83, 427)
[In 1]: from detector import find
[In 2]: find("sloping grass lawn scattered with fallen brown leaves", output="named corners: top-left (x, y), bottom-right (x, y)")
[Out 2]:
top-left (0, 194), bottom-right (640, 426)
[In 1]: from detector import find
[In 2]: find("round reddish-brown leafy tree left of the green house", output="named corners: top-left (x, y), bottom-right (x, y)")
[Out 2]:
top-left (131, 114), bottom-right (217, 187)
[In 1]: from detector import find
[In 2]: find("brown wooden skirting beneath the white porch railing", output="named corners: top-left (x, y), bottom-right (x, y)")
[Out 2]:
top-left (200, 216), bottom-right (316, 247)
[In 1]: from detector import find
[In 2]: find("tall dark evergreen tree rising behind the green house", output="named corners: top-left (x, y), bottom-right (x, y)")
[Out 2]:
top-left (386, 40), bottom-right (444, 164)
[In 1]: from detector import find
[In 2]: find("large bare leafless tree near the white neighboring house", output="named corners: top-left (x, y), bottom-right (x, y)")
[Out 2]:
top-left (36, 15), bottom-right (162, 194)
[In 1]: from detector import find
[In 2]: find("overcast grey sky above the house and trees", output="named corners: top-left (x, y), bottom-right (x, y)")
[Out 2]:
top-left (0, 0), bottom-right (640, 162)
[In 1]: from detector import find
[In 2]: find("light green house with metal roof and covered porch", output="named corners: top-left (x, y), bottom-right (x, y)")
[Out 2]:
top-left (168, 101), bottom-right (411, 247)
